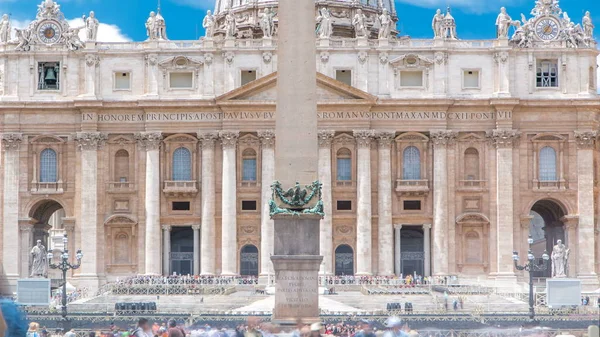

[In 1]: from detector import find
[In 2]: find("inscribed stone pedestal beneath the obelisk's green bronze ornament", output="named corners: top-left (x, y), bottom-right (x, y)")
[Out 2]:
top-left (271, 215), bottom-right (323, 325)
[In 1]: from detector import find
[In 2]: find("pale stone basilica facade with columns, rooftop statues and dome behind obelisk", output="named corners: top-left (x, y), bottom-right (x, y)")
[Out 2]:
top-left (0, 0), bottom-right (600, 293)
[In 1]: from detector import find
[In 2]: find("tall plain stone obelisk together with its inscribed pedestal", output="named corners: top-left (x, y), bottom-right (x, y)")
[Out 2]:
top-left (271, 0), bottom-right (323, 324)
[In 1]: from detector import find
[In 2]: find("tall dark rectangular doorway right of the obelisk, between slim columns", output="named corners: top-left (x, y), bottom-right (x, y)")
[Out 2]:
top-left (400, 226), bottom-right (425, 276)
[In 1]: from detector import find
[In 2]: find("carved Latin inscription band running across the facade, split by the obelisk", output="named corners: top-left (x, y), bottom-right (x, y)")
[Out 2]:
top-left (82, 111), bottom-right (512, 123)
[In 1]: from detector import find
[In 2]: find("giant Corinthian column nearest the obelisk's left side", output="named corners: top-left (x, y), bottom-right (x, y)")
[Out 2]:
top-left (258, 130), bottom-right (275, 276)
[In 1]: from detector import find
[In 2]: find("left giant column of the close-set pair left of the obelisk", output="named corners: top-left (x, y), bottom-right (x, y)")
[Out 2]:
top-left (198, 132), bottom-right (219, 275)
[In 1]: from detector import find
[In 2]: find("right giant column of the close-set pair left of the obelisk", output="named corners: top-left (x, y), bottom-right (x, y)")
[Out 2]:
top-left (219, 131), bottom-right (239, 275)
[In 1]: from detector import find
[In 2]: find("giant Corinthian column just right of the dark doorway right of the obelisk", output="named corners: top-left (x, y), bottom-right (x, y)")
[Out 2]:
top-left (431, 131), bottom-right (456, 275)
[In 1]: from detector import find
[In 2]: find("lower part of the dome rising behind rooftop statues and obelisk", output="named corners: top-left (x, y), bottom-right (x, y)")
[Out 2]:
top-left (214, 0), bottom-right (398, 38)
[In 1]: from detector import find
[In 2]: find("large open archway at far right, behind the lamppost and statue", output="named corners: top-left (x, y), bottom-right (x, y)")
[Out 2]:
top-left (529, 200), bottom-right (569, 277)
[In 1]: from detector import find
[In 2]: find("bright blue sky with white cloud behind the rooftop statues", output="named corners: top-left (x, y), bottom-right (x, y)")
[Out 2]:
top-left (0, 0), bottom-right (600, 41)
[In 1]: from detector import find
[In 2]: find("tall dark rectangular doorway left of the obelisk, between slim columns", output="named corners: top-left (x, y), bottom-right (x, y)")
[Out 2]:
top-left (170, 227), bottom-right (194, 275)
